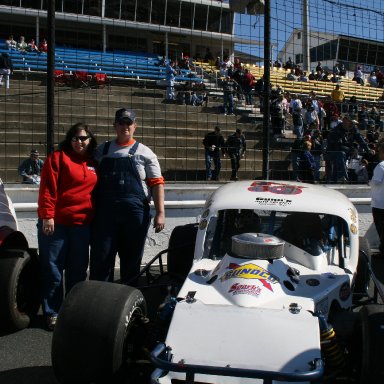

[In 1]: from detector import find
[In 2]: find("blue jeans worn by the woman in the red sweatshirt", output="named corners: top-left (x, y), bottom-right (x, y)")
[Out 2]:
top-left (37, 220), bottom-right (90, 316)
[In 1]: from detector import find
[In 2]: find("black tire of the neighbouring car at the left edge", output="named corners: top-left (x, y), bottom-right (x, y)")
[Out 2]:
top-left (0, 249), bottom-right (41, 332)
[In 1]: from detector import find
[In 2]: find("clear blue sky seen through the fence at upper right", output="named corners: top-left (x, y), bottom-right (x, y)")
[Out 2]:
top-left (235, 0), bottom-right (384, 59)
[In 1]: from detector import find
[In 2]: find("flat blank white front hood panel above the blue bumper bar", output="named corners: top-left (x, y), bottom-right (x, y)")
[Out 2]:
top-left (166, 300), bottom-right (320, 383)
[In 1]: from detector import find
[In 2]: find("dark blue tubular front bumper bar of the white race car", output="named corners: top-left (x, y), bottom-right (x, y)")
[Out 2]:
top-left (151, 343), bottom-right (324, 384)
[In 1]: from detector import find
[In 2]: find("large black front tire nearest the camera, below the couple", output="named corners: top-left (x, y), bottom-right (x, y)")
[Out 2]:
top-left (52, 281), bottom-right (147, 384)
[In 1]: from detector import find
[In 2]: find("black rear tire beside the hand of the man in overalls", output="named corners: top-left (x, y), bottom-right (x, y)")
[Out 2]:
top-left (167, 224), bottom-right (198, 281)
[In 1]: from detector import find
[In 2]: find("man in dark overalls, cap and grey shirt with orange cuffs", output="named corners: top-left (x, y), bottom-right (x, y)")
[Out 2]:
top-left (90, 108), bottom-right (165, 286)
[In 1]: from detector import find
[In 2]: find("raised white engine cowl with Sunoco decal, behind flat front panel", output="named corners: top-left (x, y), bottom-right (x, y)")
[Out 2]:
top-left (178, 255), bottom-right (352, 314)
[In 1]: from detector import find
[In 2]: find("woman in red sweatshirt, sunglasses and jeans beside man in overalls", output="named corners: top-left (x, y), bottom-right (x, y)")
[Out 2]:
top-left (37, 123), bottom-right (97, 330)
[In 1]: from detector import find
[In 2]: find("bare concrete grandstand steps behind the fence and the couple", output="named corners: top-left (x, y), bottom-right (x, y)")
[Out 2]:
top-left (0, 79), bottom-right (266, 182)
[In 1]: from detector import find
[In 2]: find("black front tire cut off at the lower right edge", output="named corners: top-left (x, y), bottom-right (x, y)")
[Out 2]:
top-left (358, 304), bottom-right (384, 384)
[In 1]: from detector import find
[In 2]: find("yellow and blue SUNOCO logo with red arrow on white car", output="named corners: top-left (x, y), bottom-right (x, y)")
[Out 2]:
top-left (220, 263), bottom-right (279, 292)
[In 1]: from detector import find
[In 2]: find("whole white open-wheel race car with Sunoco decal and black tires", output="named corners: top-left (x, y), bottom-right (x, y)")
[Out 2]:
top-left (52, 181), bottom-right (384, 384)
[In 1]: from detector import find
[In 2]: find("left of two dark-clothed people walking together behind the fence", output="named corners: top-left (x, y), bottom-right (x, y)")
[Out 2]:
top-left (203, 126), bottom-right (225, 181)
